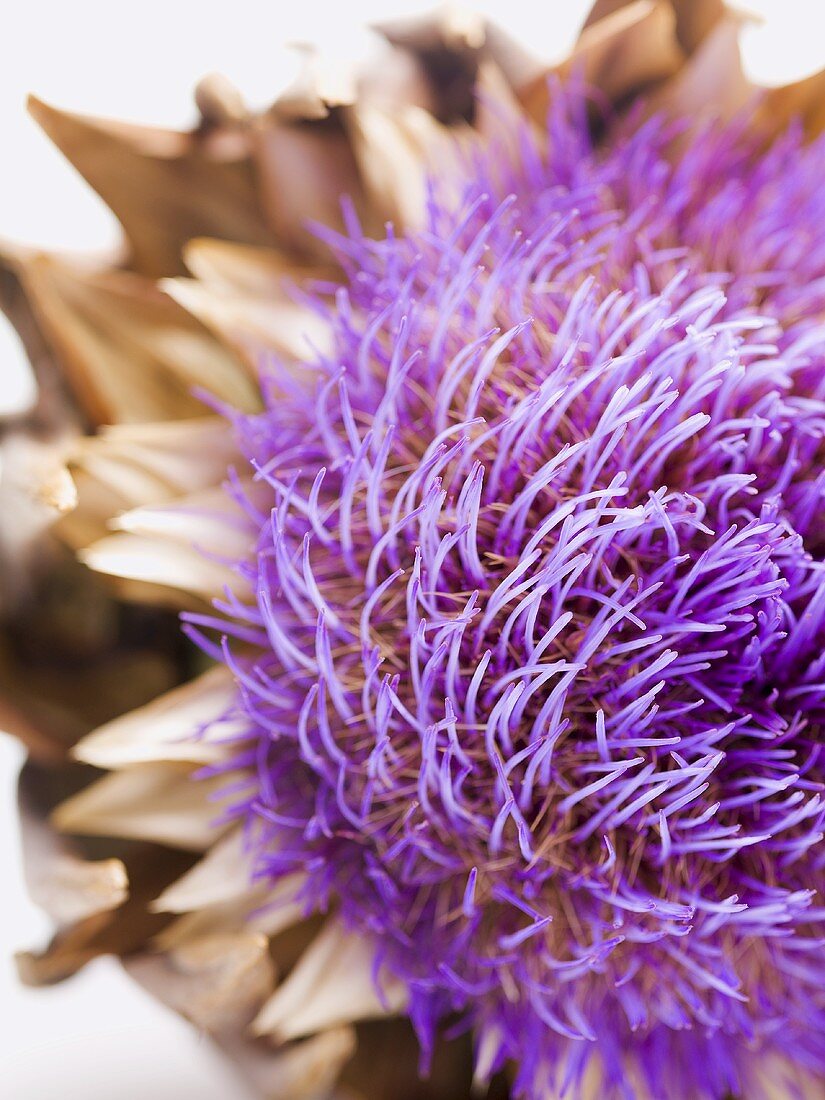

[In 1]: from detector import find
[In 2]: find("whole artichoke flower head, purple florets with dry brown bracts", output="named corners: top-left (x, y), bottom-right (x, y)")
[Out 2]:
top-left (0, 0), bottom-right (825, 1100)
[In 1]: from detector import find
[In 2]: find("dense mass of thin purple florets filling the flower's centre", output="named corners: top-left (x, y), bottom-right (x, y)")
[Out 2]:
top-left (190, 94), bottom-right (825, 1100)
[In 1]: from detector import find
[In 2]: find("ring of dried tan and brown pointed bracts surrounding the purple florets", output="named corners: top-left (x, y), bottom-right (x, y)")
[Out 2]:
top-left (0, 0), bottom-right (825, 1100)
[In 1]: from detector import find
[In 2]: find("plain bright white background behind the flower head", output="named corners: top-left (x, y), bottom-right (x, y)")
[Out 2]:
top-left (0, 0), bottom-right (825, 1100)
